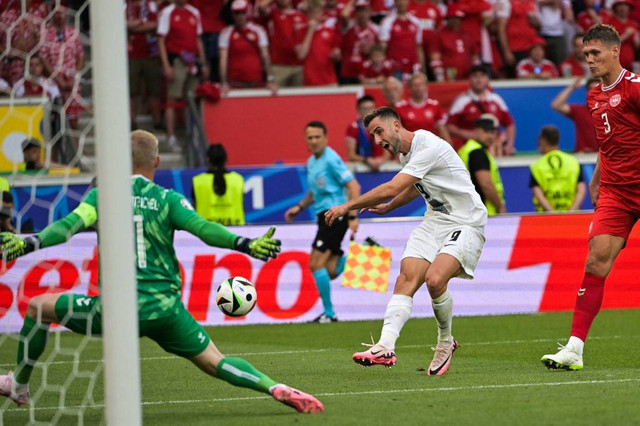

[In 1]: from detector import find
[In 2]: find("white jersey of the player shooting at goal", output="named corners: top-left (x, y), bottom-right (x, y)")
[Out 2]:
top-left (400, 130), bottom-right (487, 227)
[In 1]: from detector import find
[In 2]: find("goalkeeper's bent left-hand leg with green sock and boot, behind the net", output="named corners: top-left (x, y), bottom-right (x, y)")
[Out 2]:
top-left (0, 293), bottom-right (60, 406)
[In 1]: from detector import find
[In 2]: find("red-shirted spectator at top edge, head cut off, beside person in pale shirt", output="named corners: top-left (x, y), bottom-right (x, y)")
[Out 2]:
top-left (498, 0), bottom-right (540, 77)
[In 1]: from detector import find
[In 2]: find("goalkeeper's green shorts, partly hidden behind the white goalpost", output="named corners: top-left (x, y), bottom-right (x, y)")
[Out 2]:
top-left (55, 294), bottom-right (211, 358)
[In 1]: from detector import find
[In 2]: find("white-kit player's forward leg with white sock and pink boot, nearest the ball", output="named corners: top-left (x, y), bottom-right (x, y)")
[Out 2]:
top-left (352, 257), bottom-right (430, 367)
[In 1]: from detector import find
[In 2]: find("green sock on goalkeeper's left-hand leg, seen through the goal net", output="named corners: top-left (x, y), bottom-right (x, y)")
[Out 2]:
top-left (14, 315), bottom-right (49, 385)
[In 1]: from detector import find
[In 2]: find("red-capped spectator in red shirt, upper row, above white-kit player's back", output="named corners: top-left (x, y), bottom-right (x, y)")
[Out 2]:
top-left (429, 4), bottom-right (479, 81)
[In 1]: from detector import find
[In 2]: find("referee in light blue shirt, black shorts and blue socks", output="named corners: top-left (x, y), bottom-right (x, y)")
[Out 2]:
top-left (284, 121), bottom-right (360, 324)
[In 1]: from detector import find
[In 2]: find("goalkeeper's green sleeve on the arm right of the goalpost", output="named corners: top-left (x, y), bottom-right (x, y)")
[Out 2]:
top-left (168, 191), bottom-right (239, 249)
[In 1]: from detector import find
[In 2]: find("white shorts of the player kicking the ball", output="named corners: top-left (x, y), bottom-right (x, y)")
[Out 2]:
top-left (402, 216), bottom-right (485, 280)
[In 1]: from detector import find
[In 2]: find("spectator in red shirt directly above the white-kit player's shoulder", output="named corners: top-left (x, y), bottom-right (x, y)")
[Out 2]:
top-left (395, 73), bottom-right (451, 143)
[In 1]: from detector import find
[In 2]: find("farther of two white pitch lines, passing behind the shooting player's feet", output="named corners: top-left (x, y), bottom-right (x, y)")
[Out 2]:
top-left (0, 336), bottom-right (640, 368)
